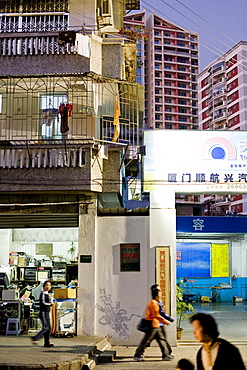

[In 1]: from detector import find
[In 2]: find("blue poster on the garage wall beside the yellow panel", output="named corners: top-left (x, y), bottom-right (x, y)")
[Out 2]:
top-left (176, 243), bottom-right (211, 278)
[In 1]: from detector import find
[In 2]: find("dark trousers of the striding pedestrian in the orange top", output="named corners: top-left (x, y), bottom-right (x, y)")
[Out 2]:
top-left (135, 327), bottom-right (169, 358)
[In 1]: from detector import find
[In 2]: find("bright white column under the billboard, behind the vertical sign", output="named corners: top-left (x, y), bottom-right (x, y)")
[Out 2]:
top-left (150, 189), bottom-right (177, 346)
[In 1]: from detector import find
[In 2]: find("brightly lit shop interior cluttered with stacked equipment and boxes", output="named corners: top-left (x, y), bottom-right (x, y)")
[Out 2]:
top-left (0, 227), bottom-right (78, 336)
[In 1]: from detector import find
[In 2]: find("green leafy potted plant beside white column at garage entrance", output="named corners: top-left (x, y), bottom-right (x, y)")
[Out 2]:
top-left (176, 283), bottom-right (195, 339)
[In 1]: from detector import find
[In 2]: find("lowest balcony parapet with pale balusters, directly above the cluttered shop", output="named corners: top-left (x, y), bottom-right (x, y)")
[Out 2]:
top-left (0, 140), bottom-right (119, 194)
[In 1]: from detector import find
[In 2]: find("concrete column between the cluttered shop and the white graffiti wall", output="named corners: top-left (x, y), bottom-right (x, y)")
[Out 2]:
top-left (77, 198), bottom-right (97, 336)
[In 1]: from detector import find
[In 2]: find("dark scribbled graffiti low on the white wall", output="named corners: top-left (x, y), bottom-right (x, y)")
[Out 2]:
top-left (97, 289), bottom-right (140, 340)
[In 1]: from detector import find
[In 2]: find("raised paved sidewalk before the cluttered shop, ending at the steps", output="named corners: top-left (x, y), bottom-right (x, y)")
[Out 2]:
top-left (0, 335), bottom-right (111, 370)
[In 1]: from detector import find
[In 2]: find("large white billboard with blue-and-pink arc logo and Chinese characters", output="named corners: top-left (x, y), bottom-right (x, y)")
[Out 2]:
top-left (144, 130), bottom-right (247, 192)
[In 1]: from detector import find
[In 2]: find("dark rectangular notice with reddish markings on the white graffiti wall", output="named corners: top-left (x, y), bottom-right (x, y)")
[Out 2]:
top-left (120, 243), bottom-right (140, 271)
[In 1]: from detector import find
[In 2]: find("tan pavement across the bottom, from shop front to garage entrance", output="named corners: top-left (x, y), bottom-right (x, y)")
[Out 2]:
top-left (0, 333), bottom-right (247, 370)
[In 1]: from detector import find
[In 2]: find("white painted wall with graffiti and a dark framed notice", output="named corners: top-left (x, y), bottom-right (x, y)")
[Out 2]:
top-left (96, 216), bottom-right (149, 345)
